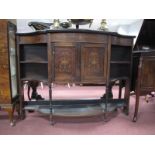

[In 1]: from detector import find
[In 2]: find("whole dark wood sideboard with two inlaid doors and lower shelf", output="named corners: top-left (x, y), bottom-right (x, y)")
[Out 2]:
top-left (17, 29), bottom-right (133, 123)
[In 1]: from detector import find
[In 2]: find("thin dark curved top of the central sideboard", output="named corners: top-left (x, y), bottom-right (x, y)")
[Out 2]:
top-left (17, 29), bottom-right (135, 38)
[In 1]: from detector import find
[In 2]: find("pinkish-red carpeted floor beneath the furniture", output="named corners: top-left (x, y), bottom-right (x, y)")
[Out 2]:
top-left (0, 86), bottom-right (155, 135)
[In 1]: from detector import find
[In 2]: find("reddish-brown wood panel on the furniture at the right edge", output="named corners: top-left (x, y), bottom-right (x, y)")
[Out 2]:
top-left (141, 57), bottom-right (155, 89)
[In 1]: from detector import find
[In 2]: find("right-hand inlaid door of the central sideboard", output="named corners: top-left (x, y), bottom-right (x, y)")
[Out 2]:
top-left (81, 43), bottom-right (107, 83)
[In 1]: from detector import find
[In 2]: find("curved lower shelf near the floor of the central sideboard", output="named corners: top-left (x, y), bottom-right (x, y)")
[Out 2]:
top-left (24, 99), bottom-right (126, 117)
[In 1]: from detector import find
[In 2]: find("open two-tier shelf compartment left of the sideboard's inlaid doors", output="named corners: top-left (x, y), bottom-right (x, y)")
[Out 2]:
top-left (19, 43), bottom-right (48, 81)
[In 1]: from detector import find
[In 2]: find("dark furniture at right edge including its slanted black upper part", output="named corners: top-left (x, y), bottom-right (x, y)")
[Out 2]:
top-left (131, 19), bottom-right (155, 122)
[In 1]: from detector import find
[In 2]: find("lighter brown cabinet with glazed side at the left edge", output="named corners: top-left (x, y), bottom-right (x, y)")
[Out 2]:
top-left (0, 20), bottom-right (18, 125)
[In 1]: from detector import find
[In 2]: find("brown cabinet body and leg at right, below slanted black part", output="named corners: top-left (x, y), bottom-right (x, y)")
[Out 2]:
top-left (132, 50), bottom-right (155, 122)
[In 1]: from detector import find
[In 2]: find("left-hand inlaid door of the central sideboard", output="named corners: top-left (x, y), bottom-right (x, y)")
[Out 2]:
top-left (53, 43), bottom-right (76, 83)
